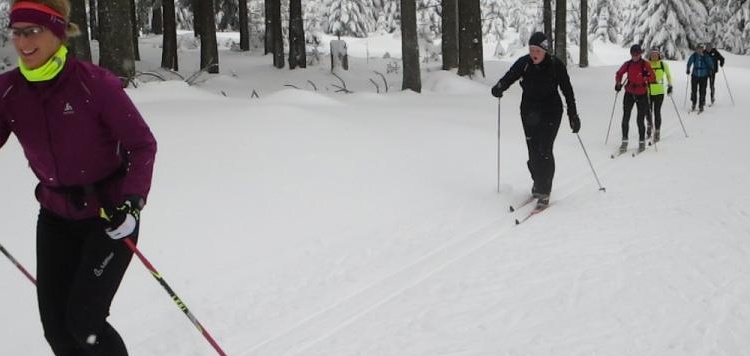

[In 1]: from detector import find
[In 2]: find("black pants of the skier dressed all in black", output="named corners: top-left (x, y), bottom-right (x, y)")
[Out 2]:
top-left (521, 110), bottom-right (562, 194)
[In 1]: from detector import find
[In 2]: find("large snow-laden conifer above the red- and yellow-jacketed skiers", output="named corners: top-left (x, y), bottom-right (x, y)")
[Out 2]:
top-left (625, 0), bottom-right (708, 59)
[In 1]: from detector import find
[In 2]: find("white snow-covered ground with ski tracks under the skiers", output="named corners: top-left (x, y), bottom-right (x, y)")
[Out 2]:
top-left (0, 33), bottom-right (750, 356)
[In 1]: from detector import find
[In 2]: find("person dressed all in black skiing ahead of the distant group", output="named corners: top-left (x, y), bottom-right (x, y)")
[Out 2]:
top-left (492, 32), bottom-right (581, 206)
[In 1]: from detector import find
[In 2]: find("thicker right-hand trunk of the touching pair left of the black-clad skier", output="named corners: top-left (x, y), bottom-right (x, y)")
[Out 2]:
top-left (458, 0), bottom-right (484, 77)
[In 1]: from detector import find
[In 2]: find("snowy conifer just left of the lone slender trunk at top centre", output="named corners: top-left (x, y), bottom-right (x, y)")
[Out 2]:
top-left (323, 0), bottom-right (375, 37)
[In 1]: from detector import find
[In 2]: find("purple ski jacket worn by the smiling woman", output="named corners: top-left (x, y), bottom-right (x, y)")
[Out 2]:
top-left (0, 56), bottom-right (156, 220)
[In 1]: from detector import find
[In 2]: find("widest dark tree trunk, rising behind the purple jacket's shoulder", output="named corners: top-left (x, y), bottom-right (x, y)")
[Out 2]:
top-left (98, 0), bottom-right (135, 79)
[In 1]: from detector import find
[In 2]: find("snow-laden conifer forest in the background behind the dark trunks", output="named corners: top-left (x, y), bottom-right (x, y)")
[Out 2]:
top-left (136, 0), bottom-right (750, 58)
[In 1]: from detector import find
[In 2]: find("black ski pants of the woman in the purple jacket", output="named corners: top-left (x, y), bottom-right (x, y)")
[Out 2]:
top-left (37, 208), bottom-right (136, 356)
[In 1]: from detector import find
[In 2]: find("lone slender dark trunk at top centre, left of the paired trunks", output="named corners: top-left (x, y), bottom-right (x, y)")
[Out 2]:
top-left (401, 0), bottom-right (420, 93)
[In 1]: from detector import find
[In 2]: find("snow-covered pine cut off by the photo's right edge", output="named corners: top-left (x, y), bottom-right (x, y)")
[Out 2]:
top-left (714, 0), bottom-right (750, 54)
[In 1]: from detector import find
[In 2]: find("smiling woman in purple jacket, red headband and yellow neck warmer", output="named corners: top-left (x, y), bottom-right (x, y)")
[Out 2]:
top-left (0, 0), bottom-right (156, 356)
